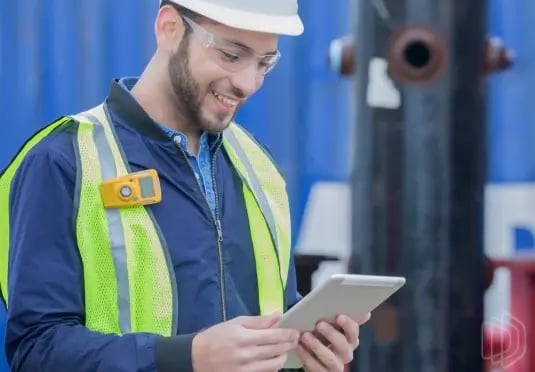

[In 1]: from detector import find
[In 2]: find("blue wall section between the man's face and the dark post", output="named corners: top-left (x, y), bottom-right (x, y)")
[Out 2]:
top-left (237, 0), bottom-right (352, 241)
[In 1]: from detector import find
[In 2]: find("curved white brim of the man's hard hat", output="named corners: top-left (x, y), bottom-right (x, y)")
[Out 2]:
top-left (165, 0), bottom-right (304, 36)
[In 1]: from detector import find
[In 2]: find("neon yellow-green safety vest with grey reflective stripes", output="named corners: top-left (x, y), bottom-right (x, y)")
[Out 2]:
top-left (0, 104), bottom-right (291, 336)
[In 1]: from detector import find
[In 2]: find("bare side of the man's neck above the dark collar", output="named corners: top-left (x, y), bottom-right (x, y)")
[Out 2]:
top-left (131, 58), bottom-right (201, 153)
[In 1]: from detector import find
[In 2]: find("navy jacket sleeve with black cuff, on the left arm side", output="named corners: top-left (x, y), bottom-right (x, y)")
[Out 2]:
top-left (2, 141), bottom-right (193, 372)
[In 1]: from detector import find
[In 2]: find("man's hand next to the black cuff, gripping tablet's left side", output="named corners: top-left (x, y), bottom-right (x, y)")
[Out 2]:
top-left (191, 315), bottom-right (299, 372)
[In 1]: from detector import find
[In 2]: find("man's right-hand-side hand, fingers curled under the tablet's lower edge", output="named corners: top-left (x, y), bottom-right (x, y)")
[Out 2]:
top-left (297, 313), bottom-right (371, 372)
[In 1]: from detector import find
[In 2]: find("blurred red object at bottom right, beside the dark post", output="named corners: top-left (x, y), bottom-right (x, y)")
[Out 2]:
top-left (482, 256), bottom-right (535, 372)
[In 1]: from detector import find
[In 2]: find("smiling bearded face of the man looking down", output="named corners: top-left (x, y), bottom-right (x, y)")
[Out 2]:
top-left (168, 17), bottom-right (277, 133)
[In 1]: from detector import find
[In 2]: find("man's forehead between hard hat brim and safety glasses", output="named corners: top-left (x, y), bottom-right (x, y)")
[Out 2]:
top-left (198, 19), bottom-right (278, 54)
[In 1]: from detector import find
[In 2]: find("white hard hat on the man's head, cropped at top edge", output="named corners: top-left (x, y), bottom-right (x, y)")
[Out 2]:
top-left (163, 0), bottom-right (303, 35)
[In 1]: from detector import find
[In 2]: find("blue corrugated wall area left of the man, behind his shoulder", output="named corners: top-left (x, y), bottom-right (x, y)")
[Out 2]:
top-left (0, 0), bottom-right (158, 168)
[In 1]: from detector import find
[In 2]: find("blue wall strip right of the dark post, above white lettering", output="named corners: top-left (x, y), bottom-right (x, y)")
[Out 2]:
top-left (488, 0), bottom-right (535, 183)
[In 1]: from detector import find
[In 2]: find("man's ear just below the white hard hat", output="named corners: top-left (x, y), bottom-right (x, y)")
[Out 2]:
top-left (154, 5), bottom-right (185, 51)
